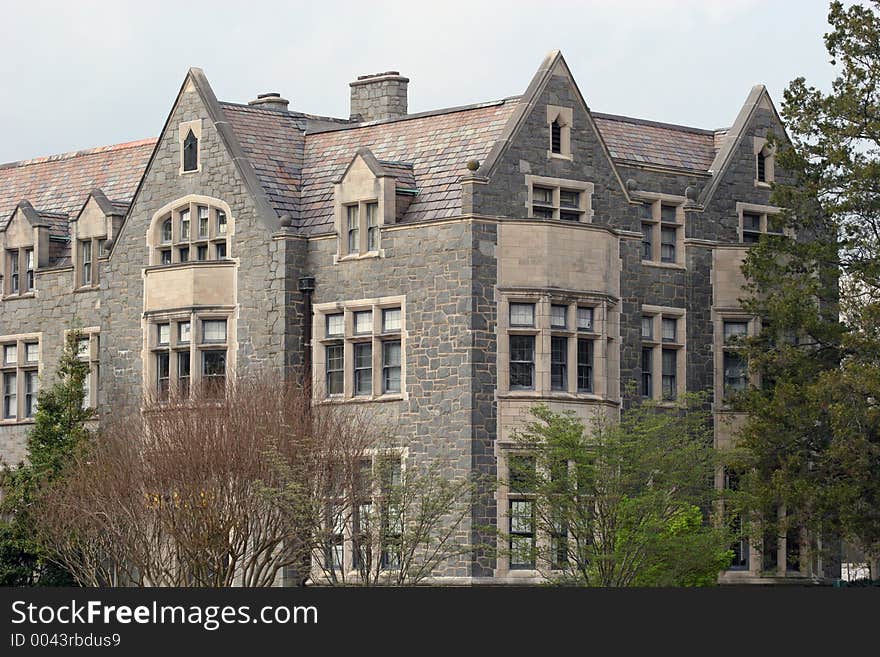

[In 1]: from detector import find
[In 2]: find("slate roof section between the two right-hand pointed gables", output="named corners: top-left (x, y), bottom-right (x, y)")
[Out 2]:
top-left (593, 112), bottom-right (716, 173)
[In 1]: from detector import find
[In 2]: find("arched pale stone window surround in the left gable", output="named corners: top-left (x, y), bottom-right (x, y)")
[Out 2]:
top-left (146, 194), bottom-right (235, 266)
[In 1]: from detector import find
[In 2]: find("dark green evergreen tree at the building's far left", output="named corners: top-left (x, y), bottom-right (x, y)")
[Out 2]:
top-left (0, 330), bottom-right (94, 586)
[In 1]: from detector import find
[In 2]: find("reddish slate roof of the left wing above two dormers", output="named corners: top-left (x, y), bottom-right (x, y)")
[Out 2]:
top-left (0, 138), bottom-right (156, 235)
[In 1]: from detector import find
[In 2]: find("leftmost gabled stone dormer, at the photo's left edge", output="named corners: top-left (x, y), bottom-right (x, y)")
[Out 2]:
top-left (0, 199), bottom-right (69, 299)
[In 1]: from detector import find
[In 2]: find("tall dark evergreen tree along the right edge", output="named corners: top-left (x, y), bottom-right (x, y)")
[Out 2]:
top-left (736, 2), bottom-right (880, 577)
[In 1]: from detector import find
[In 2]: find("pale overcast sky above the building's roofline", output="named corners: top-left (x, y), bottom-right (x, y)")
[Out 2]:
top-left (0, 0), bottom-right (833, 162)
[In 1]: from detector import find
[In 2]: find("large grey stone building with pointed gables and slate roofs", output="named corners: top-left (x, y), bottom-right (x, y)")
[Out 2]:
top-left (0, 52), bottom-right (823, 582)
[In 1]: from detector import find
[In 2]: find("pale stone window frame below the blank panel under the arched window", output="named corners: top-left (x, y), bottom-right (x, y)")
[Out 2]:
top-left (141, 307), bottom-right (232, 396)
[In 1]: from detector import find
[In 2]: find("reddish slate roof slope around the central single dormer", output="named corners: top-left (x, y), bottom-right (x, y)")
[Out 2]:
top-left (300, 99), bottom-right (518, 234)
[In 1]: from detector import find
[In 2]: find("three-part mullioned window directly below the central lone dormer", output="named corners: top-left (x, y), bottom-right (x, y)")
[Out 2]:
top-left (313, 297), bottom-right (406, 399)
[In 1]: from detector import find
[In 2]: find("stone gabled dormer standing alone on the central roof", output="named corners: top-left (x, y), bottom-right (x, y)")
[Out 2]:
top-left (333, 147), bottom-right (418, 261)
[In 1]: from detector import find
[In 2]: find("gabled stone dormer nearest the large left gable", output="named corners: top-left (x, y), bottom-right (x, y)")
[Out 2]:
top-left (70, 189), bottom-right (128, 290)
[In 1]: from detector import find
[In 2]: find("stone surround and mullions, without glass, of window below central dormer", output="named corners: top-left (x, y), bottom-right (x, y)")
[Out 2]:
top-left (312, 295), bottom-right (409, 403)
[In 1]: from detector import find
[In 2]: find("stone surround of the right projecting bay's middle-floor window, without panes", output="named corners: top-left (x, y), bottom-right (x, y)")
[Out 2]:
top-left (497, 290), bottom-right (617, 400)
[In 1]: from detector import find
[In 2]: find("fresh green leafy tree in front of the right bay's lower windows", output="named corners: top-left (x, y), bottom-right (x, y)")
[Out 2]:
top-left (505, 397), bottom-right (731, 586)
